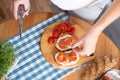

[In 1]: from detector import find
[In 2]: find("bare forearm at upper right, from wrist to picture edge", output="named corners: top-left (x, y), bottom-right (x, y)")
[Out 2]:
top-left (91, 0), bottom-right (120, 35)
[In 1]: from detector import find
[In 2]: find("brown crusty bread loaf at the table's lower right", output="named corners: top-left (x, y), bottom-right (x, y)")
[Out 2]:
top-left (80, 54), bottom-right (118, 80)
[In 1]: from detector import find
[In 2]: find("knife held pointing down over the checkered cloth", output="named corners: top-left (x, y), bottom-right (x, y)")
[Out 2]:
top-left (18, 4), bottom-right (25, 38)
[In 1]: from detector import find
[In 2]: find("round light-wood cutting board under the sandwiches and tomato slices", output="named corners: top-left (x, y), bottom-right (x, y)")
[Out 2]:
top-left (40, 21), bottom-right (95, 69)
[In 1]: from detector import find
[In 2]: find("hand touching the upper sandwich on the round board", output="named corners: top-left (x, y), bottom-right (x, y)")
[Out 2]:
top-left (72, 31), bottom-right (99, 56)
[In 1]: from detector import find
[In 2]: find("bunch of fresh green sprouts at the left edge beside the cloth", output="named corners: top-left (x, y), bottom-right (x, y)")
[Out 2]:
top-left (0, 41), bottom-right (15, 79)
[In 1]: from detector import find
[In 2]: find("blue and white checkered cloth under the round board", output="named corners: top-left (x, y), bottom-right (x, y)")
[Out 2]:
top-left (7, 12), bottom-right (78, 80)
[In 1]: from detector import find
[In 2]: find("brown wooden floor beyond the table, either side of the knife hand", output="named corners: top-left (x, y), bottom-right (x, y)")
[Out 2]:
top-left (0, 0), bottom-right (52, 23)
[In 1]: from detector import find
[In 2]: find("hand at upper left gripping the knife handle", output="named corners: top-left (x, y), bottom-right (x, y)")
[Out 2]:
top-left (11, 0), bottom-right (30, 20)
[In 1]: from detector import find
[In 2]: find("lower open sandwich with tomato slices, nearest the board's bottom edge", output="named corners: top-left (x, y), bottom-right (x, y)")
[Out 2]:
top-left (55, 50), bottom-right (80, 66)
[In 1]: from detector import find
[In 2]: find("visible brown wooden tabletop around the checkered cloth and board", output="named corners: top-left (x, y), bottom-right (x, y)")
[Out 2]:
top-left (0, 13), bottom-right (120, 80)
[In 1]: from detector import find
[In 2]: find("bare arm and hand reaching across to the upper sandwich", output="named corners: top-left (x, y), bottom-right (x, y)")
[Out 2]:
top-left (72, 0), bottom-right (120, 56)
